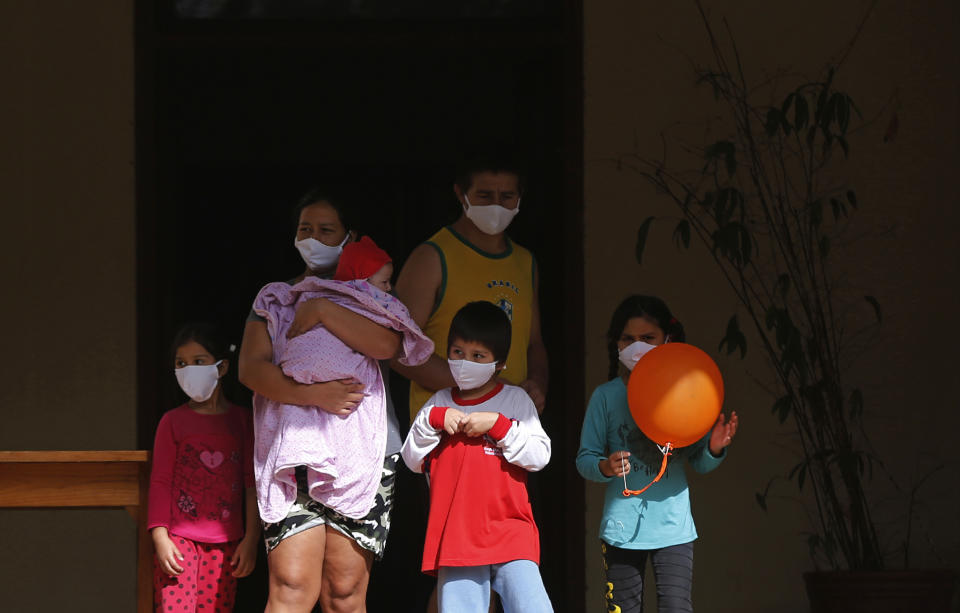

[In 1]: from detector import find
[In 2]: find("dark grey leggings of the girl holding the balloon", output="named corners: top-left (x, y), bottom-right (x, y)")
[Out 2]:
top-left (602, 542), bottom-right (693, 613)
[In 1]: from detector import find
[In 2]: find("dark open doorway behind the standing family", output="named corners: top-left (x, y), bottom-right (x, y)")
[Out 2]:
top-left (136, 0), bottom-right (584, 613)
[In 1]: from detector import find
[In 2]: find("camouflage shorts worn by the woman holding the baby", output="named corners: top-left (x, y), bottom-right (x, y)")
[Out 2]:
top-left (263, 453), bottom-right (400, 560)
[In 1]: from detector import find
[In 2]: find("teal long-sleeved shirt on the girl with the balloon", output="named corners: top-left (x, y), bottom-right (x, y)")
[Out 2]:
top-left (577, 377), bottom-right (726, 549)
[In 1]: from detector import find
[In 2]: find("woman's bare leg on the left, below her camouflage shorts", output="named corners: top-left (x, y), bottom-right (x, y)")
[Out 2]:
top-left (264, 526), bottom-right (327, 613)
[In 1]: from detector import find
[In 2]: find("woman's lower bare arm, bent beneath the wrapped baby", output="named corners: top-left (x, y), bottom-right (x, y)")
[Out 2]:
top-left (238, 320), bottom-right (364, 415)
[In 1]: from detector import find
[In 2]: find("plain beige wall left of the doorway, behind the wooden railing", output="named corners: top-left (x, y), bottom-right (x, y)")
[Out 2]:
top-left (0, 0), bottom-right (136, 611)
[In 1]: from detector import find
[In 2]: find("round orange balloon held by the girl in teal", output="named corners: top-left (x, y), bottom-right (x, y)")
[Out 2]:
top-left (627, 343), bottom-right (723, 447)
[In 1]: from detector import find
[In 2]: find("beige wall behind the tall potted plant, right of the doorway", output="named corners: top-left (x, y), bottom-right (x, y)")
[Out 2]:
top-left (584, 0), bottom-right (960, 613)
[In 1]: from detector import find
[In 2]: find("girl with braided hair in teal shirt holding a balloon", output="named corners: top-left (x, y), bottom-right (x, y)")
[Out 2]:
top-left (577, 296), bottom-right (737, 613)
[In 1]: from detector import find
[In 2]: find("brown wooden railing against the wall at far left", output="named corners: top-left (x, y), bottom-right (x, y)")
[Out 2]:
top-left (0, 451), bottom-right (153, 613)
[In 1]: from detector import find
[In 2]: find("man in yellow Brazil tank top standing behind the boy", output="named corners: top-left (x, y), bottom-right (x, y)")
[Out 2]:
top-left (393, 155), bottom-right (548, 419)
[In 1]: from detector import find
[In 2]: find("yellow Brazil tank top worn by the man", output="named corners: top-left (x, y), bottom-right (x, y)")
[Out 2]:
top-left (410, 226), bottom-right (535, 421)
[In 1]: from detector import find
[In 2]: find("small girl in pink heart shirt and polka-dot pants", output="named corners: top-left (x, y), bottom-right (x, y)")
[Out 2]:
top-left (147, 324), bottom-right (260, 612)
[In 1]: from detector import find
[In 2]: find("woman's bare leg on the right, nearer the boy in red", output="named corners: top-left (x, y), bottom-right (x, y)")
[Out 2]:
top-left (320, 527), bottom-right (373, 613)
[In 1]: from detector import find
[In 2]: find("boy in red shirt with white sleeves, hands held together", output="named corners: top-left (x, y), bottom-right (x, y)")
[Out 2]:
top-left (400, 301), bottom-right (553, 613)
